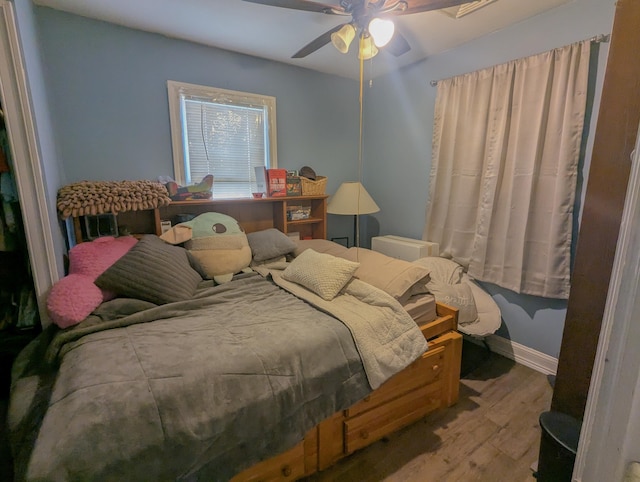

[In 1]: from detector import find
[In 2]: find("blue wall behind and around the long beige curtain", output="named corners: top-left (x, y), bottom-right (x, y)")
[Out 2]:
top-left (365, 0), bottom-right (615, 357)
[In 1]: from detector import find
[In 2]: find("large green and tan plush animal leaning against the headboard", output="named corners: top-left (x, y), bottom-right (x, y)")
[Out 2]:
top-left (160, 212), bottom-right (252, 283)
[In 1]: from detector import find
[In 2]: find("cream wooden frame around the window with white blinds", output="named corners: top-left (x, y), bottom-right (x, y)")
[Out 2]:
top-left (167, 80), bottom-right (278, 189)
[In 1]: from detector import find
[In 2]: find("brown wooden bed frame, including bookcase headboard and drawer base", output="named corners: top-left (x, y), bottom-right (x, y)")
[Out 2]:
top-left (67, 195), bottom-right (462, 482)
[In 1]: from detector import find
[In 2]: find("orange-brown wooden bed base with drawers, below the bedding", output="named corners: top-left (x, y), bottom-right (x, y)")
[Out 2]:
top-left (232, 303), bottom-right (462, 482)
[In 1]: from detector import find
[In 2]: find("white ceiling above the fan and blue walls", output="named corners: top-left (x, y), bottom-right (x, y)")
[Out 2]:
top-left (34, 0), bottom-right (573, 79)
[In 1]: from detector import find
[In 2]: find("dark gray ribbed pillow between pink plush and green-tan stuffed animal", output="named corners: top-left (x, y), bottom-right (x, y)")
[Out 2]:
top-left (95, 235), bottom-right (202, 305)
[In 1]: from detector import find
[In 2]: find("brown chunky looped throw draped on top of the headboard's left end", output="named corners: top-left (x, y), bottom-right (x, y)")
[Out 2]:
top-left (57, 181), bottom-right (171, 218)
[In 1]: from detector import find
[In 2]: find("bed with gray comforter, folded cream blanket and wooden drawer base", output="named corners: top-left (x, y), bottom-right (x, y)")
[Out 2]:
top-left (8, 208), bottom-right (461, 481)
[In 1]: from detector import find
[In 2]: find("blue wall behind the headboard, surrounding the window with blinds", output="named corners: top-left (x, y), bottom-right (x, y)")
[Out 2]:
top-left (36, 7), bottom-right (358, 240)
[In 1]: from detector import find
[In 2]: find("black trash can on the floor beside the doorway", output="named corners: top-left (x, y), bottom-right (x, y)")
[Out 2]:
top-left (536, 411), bottom-right (582, 482)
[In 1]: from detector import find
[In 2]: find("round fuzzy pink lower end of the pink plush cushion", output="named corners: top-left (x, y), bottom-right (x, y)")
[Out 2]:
top-left (47, 274), bottom-right (103, 328)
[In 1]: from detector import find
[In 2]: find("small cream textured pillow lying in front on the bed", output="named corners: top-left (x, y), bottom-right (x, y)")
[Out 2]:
top-left (282, 249), bottom-right (360, 301)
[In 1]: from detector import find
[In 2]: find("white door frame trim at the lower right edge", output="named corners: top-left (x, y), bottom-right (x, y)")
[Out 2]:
top-left (573, 123), bottom-right (640, 482)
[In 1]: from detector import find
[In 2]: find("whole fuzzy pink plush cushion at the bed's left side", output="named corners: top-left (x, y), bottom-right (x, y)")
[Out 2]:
top-left (47, 236), bottom-right (138, 328)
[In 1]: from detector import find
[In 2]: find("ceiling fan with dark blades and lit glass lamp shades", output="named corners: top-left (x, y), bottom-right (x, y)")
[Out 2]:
top-left (244, 0), bottom-right (471, 59)
